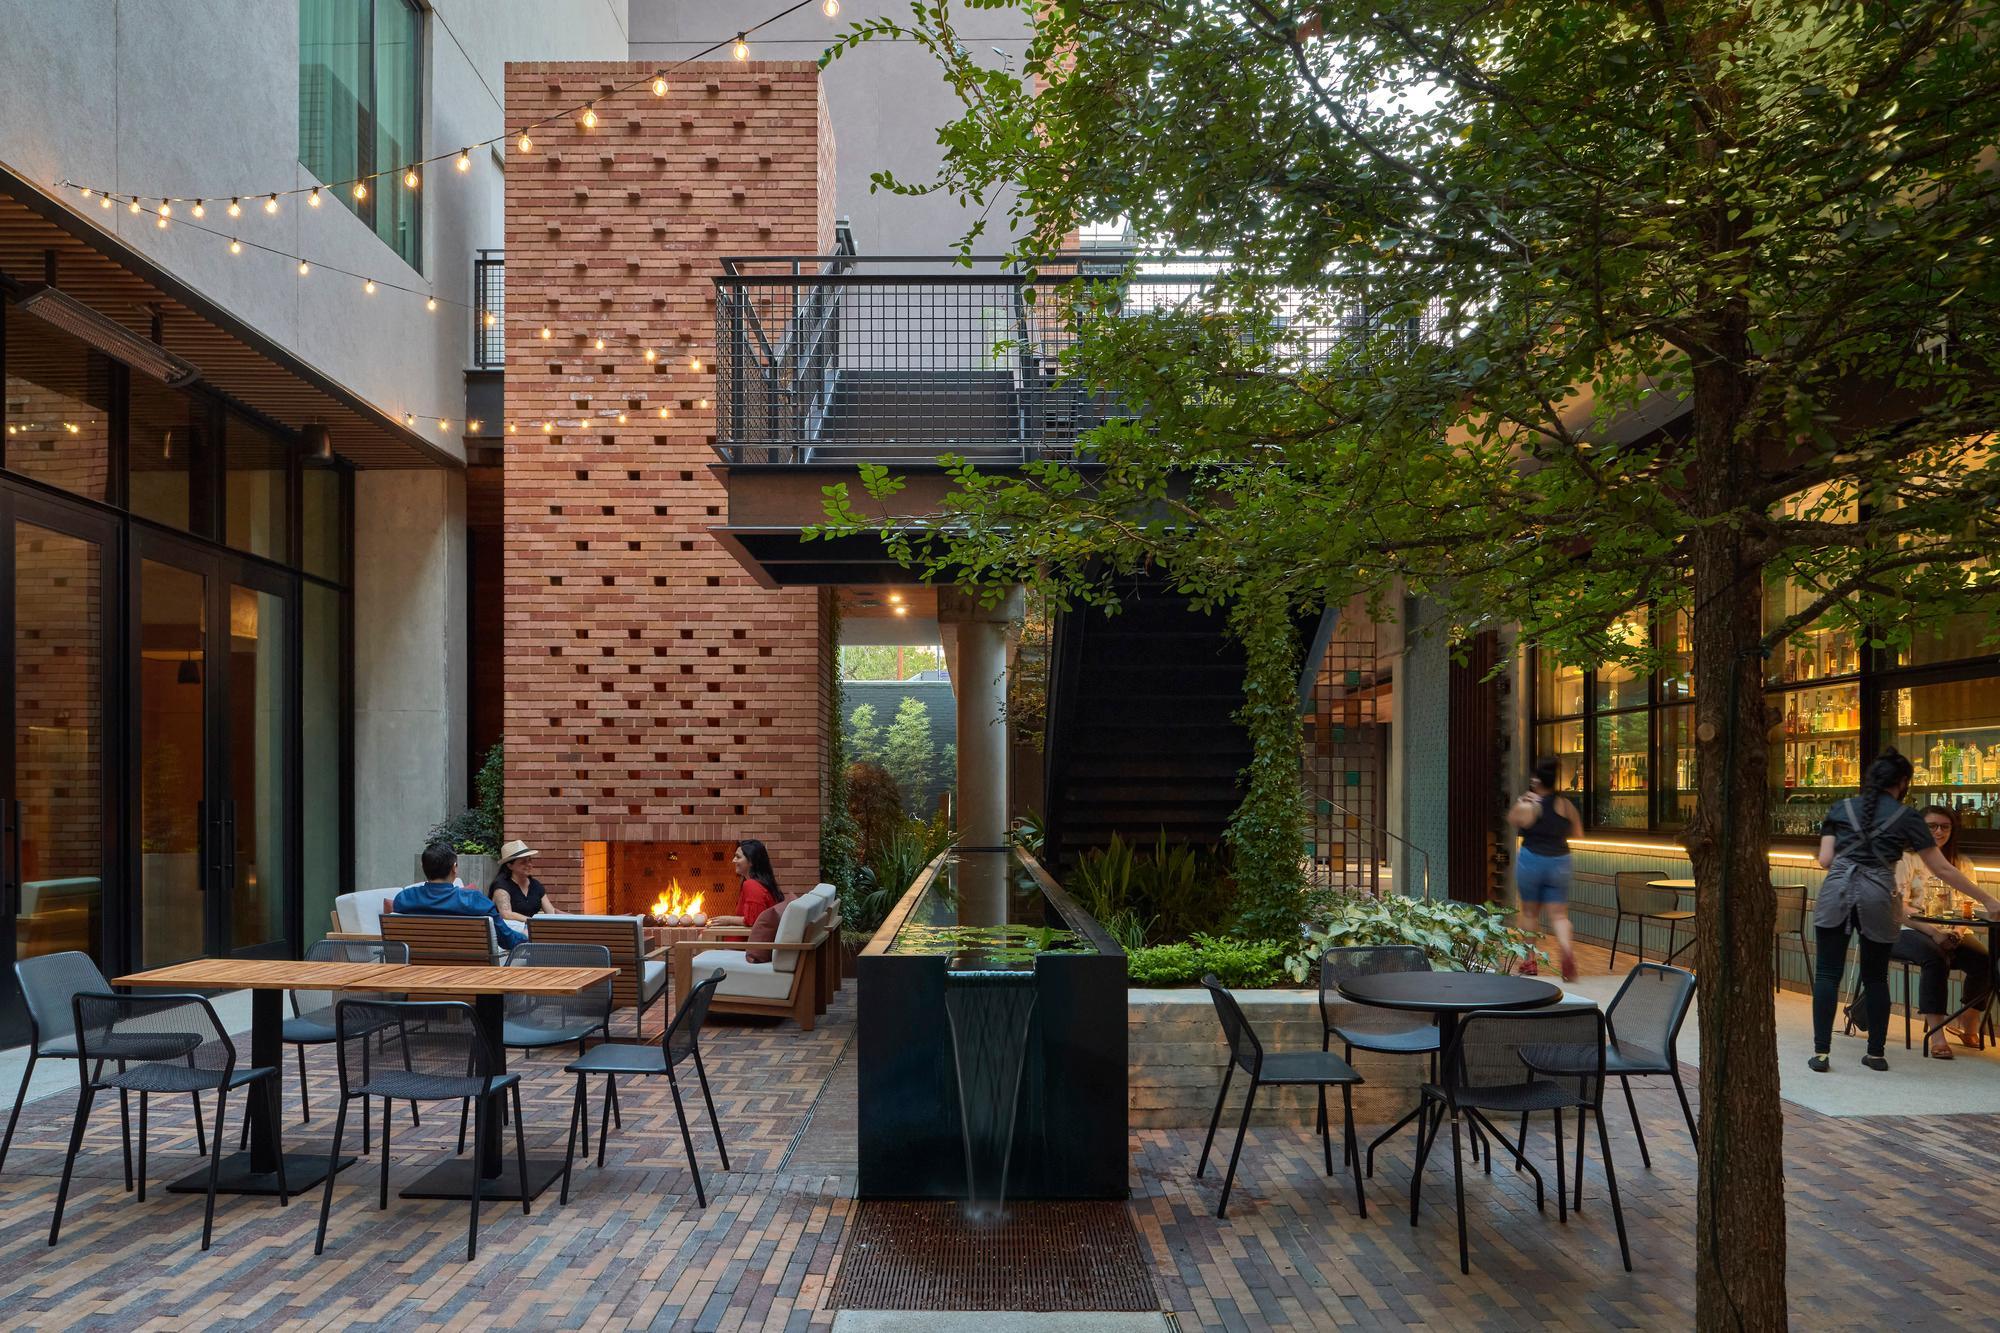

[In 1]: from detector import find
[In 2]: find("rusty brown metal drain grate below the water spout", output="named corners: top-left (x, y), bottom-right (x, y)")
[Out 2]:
top-left (832, 1201), bottom-right (1160, 1311)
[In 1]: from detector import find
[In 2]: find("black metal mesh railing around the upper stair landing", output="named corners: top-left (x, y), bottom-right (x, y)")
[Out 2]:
top-left (716, 228), bottom-right (1438, 464)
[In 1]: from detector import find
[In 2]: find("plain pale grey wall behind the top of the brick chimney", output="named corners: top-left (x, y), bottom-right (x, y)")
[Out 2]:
top-left (632, 0), bottom-right (1028, 254)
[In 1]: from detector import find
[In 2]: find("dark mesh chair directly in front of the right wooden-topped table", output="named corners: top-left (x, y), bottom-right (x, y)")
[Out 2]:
top-left (312, 999), bottom-right (528, 1263)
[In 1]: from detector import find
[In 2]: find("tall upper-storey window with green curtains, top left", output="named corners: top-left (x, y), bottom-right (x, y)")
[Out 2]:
top-left (298, 0), bottom-right (424, 268)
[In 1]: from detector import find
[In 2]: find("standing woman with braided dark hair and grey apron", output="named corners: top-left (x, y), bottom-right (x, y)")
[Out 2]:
top-left (1808, 749), bottom-right (1996, 1073)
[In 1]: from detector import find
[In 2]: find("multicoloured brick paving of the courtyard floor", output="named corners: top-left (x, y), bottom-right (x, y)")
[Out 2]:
top-left (0, 987), bottom-right (2000, 1331)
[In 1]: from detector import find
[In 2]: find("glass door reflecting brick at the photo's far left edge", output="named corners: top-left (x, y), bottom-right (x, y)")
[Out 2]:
top-left (0, 484), bottom-right (116, 1047)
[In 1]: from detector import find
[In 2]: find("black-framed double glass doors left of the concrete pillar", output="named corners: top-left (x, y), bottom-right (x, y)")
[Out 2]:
top-left (132, 532), bottom-right (296, 967)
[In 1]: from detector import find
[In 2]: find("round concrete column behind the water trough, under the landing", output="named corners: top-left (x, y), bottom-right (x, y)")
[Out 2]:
top-left (938, 588), bottom-right (1022, 925)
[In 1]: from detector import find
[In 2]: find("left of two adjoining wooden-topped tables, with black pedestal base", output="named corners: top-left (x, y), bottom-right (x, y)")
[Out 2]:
top-left (112, 959), bottom-right (396, 1195)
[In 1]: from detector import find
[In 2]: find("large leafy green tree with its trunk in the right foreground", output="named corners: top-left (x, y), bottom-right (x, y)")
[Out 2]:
top-left (828, 0), bottom-right (2000, 1329)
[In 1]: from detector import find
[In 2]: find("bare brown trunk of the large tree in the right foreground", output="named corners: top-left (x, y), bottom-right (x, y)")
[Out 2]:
top-left (1686, 356), bottom-right (1786, 1333)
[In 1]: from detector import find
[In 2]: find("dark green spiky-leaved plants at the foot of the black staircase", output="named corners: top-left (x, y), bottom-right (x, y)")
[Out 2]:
top-left (1064, 831), bottom-right (1236, 947)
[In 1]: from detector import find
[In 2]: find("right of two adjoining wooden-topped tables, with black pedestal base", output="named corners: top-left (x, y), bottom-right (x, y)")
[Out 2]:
top-left (368, 965), bottom-right (618, 1199)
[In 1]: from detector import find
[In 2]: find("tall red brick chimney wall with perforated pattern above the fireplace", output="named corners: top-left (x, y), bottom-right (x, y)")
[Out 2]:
top-left (502, 62), bottom-right (832, 909)
